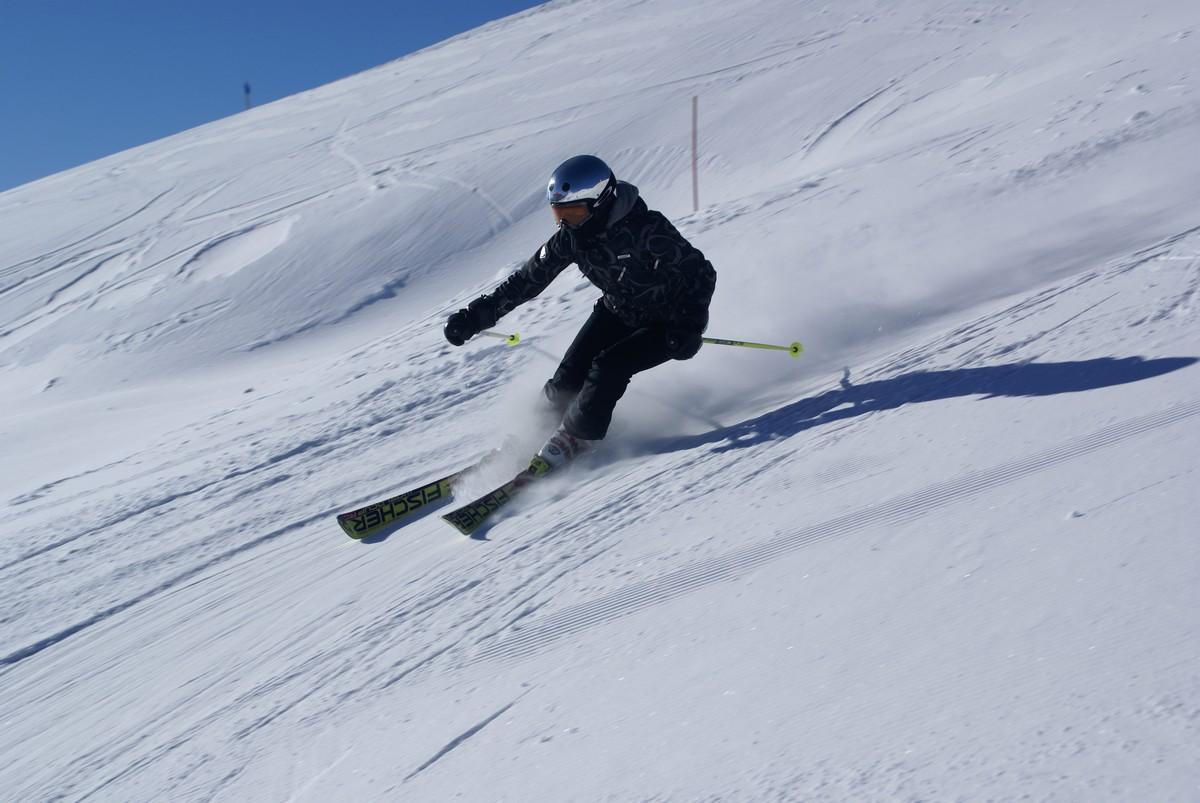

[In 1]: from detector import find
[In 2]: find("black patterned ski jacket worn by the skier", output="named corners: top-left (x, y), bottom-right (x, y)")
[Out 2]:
top-left (470, 181), bottom-right (716, 332)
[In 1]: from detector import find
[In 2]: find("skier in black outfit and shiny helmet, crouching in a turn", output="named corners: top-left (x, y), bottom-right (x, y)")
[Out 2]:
top-left (444, 156), bottom-right (716, 467)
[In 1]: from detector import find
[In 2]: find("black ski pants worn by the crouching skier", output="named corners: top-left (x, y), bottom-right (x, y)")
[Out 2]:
top-left (545, 299), bottom-right (671, 441)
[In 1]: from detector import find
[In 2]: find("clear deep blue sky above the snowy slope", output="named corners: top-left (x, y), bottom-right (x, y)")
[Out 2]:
top-left (0, 0), bottom-right (539, 192)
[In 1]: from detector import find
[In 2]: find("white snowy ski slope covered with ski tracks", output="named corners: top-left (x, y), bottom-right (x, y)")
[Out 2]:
top-left (0, 0), bottom-right (1200, 801)
